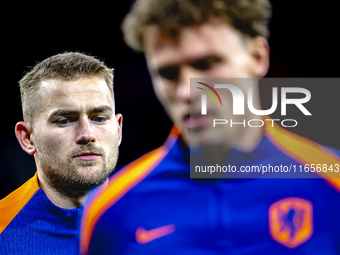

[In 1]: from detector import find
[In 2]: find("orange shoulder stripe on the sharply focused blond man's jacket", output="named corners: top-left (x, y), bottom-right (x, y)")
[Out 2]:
top-left (0, 173), bottom-right (40, 234)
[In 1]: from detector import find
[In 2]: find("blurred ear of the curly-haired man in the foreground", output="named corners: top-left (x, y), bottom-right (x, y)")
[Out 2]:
top-left (249, 36), bottom-right (269, 78)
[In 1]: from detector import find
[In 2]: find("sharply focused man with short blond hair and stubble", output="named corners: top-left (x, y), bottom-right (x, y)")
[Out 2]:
top-left (0, 52), bottom-right (122, 255)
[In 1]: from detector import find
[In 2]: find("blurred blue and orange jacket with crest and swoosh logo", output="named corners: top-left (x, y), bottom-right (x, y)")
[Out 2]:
top-left (80, 122), bottom-right (340, 255)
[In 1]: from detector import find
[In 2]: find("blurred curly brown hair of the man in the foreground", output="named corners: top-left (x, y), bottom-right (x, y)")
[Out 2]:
top-left (122, 0), bottom-right (271, 51)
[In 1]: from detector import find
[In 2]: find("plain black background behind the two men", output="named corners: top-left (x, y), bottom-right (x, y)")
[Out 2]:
top-left (0, 0), bottom-right (340, 198)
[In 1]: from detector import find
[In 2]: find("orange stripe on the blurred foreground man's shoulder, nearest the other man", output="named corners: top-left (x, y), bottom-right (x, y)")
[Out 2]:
top-left (80, 127), bottom-right (180, 254)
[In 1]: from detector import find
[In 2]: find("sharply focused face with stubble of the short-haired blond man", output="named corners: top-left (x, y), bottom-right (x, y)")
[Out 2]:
top-left (31, 78), bottom-right (121, 195)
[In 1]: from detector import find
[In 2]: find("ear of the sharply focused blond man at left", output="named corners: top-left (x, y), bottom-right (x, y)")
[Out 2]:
top-left (15, 121), bottom-right (37, 155)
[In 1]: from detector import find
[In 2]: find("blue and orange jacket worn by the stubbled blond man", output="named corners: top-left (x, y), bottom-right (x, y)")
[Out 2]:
top-left (0, 173), bottom-right (82, 255)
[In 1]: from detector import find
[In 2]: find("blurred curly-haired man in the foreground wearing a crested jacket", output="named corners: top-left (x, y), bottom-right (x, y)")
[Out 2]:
top-left (80, 0), bottom-right (340, 255)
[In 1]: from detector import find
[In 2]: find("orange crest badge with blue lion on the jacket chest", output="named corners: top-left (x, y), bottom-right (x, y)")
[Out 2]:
top-left (268, 197), bottom-right (313, 249)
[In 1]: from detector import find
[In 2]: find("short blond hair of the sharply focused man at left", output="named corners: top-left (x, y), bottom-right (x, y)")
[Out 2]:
top-left (19, 52), bottom-right (113, 124)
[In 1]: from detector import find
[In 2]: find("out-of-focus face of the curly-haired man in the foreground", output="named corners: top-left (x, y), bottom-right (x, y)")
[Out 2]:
top-left (144, 21), bottom-right (266, 146)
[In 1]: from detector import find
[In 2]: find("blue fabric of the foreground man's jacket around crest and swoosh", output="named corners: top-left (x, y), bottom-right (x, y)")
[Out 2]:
top-left (89, 136), bottom-right (340, 255)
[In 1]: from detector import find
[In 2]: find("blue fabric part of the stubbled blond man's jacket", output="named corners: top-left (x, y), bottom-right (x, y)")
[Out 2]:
top-left (0, 189), bottom-right (82, 255)
